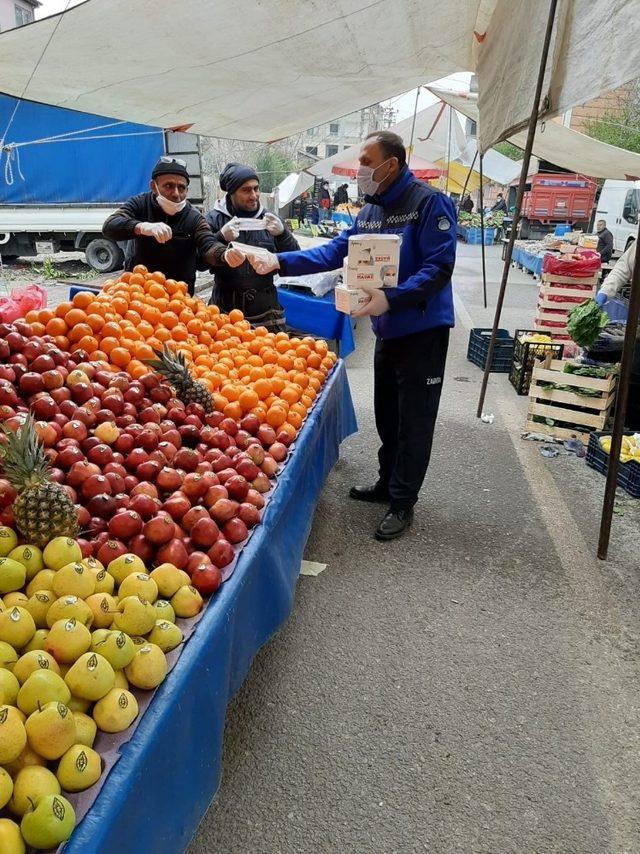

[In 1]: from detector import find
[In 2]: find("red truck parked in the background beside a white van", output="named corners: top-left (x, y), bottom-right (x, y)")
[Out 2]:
top-left (520, 172), bottom-right (596, 240)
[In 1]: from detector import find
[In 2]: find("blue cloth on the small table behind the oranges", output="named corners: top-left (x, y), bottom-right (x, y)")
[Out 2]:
top-left (278, 288), bottom-right (356, 359)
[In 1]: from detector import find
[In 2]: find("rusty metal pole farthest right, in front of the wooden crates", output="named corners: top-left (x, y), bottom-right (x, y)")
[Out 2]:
top-left (598, 227), bottom-right (640, 560)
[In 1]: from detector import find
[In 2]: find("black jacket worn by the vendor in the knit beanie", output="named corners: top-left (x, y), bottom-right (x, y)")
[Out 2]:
top-left (206, 195), bottom-right (300, 316)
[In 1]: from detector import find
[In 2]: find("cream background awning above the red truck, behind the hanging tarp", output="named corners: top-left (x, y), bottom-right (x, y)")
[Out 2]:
top-left (429, 86), bottom-right (640, 181)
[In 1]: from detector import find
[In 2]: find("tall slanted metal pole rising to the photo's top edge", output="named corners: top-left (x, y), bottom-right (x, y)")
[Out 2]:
top-left (476, 0), bottom-right (558, 418)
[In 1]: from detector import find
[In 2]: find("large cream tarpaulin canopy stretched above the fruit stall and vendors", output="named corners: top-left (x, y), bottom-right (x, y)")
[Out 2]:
top-left (0, 0), bottom-right (484, 142)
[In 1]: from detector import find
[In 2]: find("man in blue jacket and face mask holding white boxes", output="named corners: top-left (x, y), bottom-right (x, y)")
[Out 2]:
top-left (249, 131), bottom-right (456, 540)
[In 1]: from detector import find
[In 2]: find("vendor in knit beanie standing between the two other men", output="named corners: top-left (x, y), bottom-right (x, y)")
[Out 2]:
top-left (206, 163), bottom-right (300, 332)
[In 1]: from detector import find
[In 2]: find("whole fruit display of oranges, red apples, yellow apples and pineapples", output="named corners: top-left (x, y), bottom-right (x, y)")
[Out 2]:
top-left (0, 267), bottom-right (335, 852)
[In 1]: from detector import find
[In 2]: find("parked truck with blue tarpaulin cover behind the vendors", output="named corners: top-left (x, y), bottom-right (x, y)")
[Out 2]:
top-left (0, 95), bottom-right (203, 273)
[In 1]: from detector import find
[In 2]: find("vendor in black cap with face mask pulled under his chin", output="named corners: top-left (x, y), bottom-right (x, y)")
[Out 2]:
top-left (102, 157), bottom-right (245, 294)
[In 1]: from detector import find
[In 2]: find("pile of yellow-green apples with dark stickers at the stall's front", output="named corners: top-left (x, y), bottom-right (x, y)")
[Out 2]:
top-left (0, 527), bottom-right (203, 854)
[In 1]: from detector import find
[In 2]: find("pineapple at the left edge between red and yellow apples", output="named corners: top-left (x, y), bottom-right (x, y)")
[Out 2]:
top-left (0, 419), bottom-right (78, 549)
